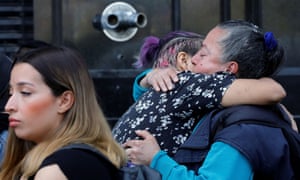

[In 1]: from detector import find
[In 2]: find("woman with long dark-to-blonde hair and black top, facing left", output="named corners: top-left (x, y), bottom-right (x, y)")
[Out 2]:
top-left (0, 47), bottom-right (126, 180)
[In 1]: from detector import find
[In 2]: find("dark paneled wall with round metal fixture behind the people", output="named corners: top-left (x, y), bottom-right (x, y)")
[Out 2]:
top-left (0, 0), bottom-right (300, 128)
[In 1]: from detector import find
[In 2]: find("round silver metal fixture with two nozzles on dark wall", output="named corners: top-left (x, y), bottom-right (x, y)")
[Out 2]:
top-left (93, 2), bottom-right (147, 42)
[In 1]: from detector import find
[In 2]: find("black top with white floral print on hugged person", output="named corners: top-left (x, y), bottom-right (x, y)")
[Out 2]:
top-left (112, 72), bottom-right (235, 156)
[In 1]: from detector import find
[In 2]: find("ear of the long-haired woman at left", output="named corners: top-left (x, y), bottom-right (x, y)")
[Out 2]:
top-left (58, 91), bottom-right (74, 113)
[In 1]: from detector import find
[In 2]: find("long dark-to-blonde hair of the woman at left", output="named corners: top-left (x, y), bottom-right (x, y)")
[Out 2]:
top-left (0, 47), bottom-right (126, 179)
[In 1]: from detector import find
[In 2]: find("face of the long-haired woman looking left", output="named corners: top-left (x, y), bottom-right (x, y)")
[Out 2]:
top-left (5, 63), bottom-right (63, 143)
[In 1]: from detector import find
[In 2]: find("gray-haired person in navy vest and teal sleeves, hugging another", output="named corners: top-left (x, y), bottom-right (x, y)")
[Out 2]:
top-left (124, 20), bottom-right (299, 180)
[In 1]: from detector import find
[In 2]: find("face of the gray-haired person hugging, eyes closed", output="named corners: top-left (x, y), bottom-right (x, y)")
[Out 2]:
top-left (190, 27), bottom-right (227, 74)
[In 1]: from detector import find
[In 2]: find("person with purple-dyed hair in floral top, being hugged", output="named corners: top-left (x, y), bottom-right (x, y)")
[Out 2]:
top-left (112, 28), bottom-right (285, 157)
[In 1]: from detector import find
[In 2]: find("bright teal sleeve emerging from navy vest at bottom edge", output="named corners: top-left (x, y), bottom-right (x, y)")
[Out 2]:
top-left (150, 142), bottom-right (253, 180)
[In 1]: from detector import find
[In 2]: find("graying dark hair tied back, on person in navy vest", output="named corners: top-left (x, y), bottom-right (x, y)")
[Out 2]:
top-left (217, 20), bottom-right (284, 78)
